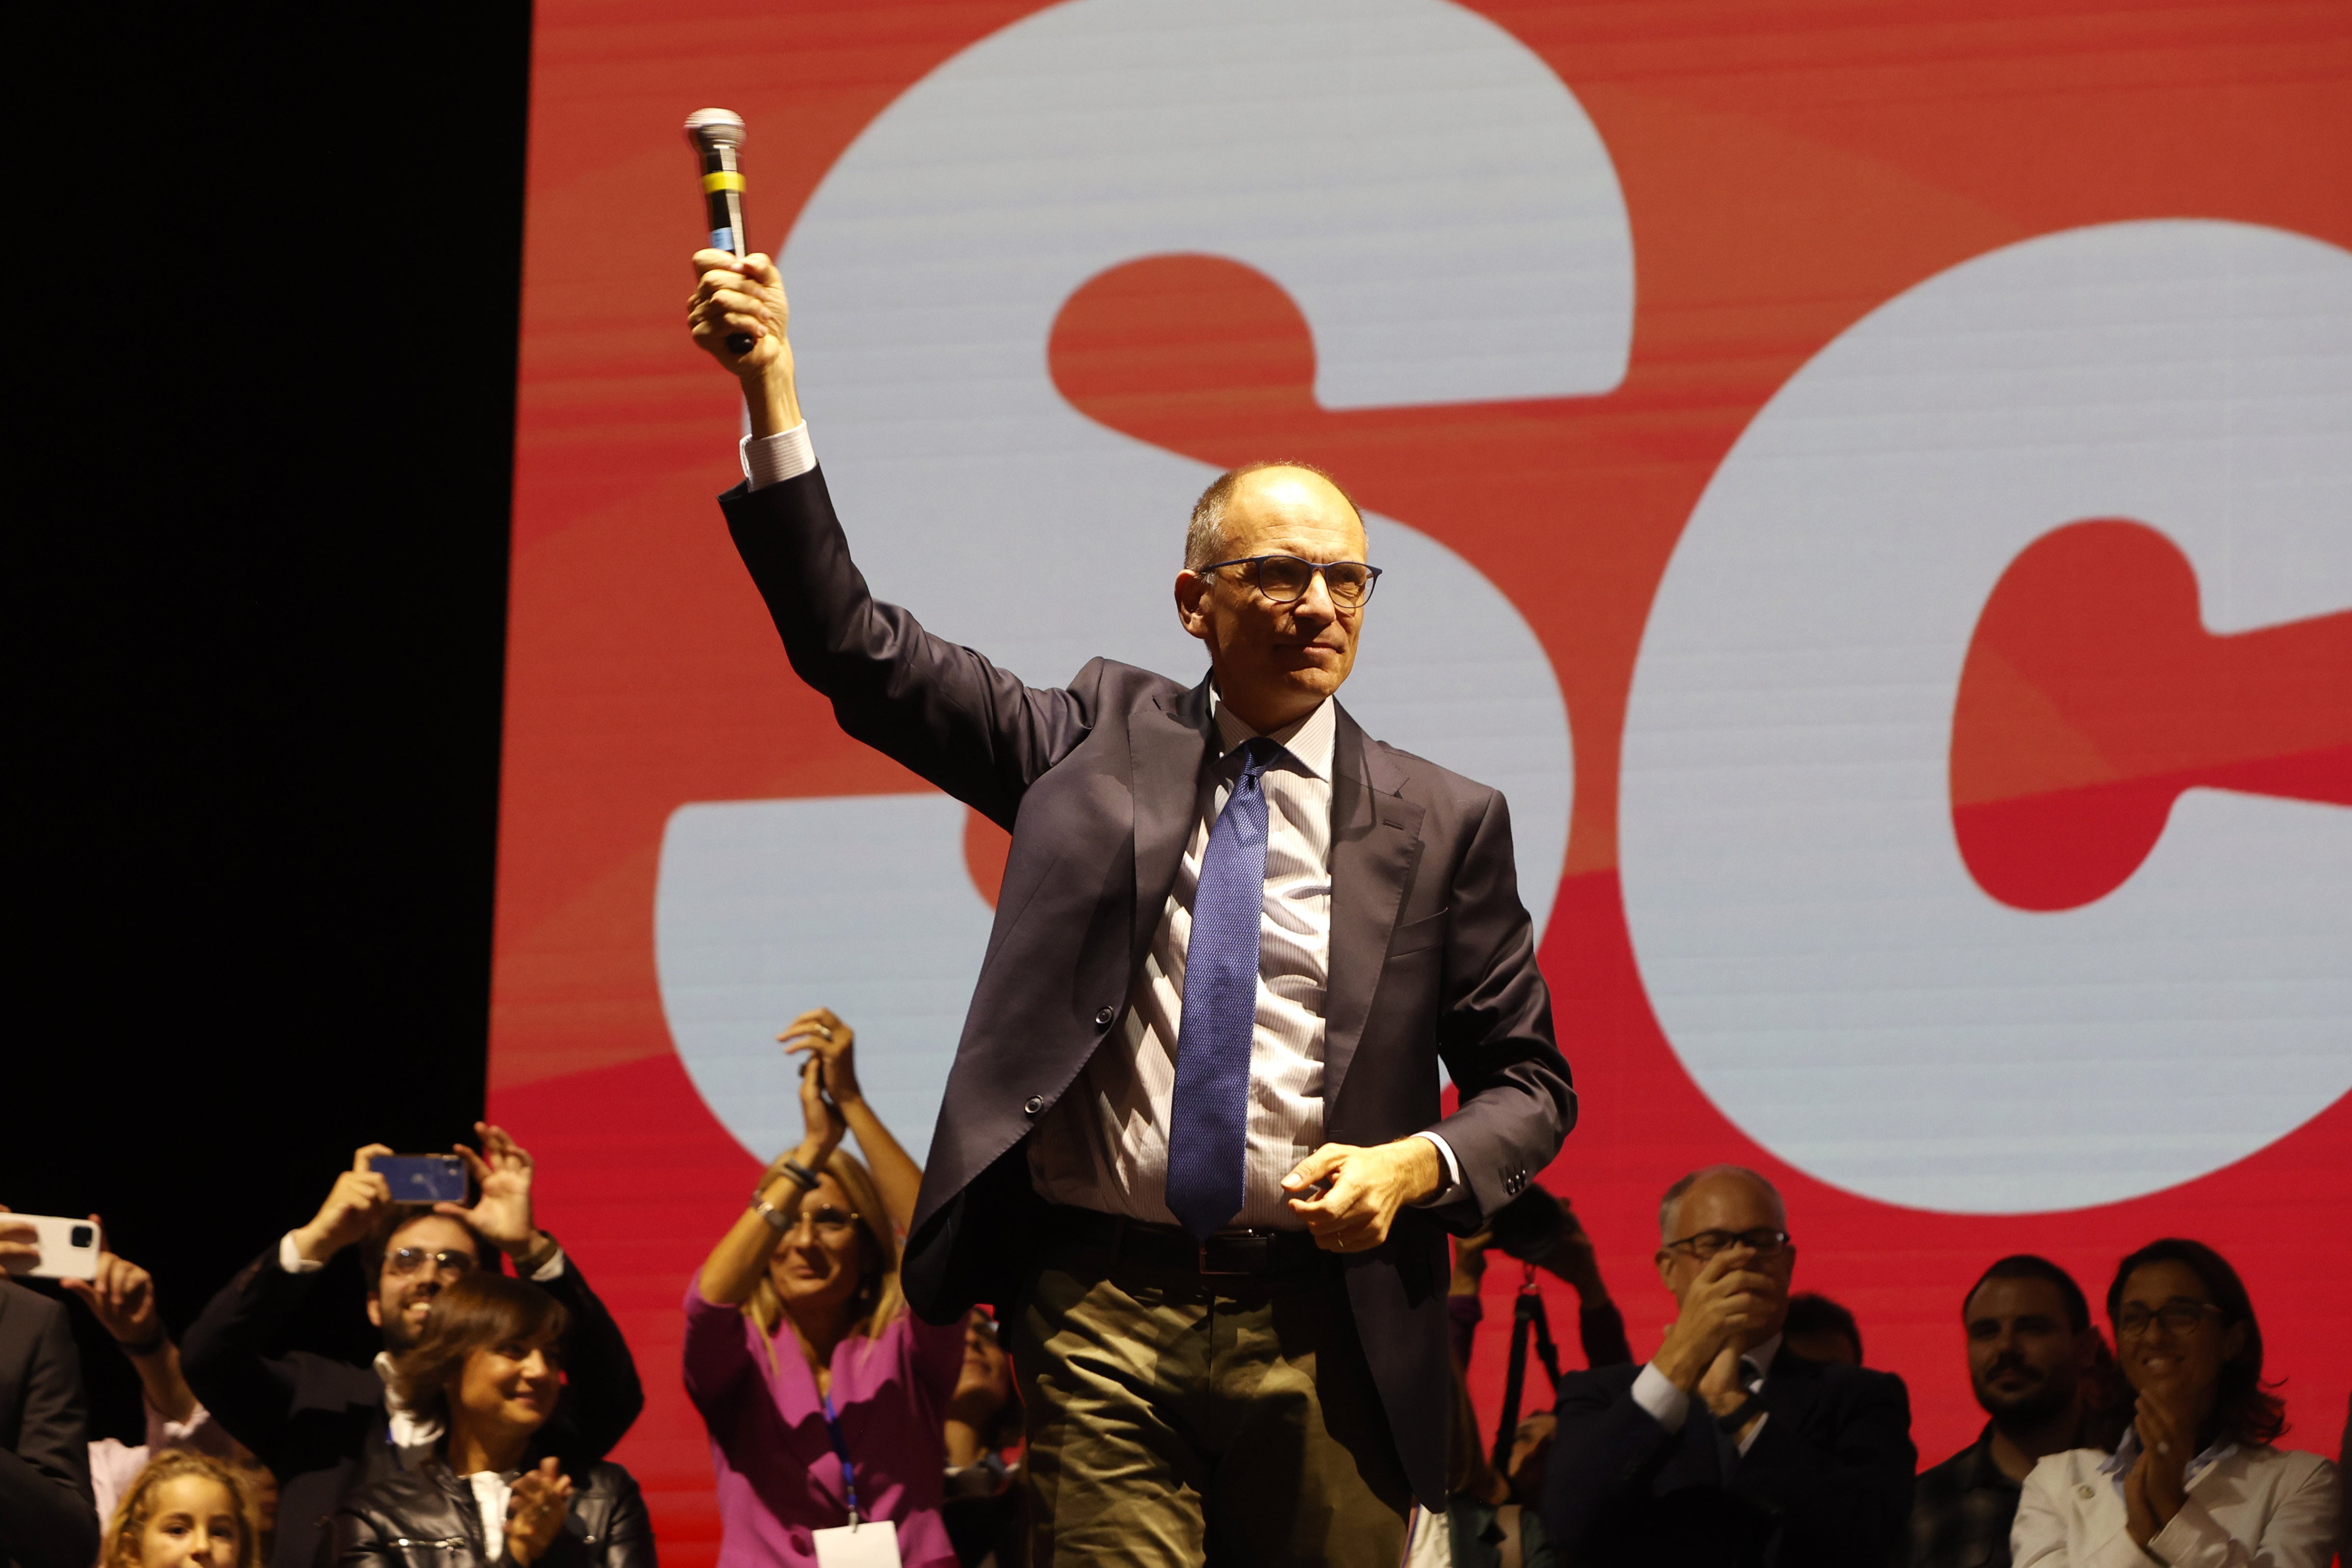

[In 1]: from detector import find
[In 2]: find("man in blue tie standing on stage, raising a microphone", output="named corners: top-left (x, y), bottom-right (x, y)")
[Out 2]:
top-left (689, 251), bottom-right (1576, 1563)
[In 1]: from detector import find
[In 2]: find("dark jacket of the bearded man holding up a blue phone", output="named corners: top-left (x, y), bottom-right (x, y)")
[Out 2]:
top-left (179, 1246), bottom-right (644, 1568)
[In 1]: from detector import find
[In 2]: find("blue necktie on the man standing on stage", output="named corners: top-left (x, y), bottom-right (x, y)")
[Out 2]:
top-left (1167, 736), bottom-right (1282, 1239)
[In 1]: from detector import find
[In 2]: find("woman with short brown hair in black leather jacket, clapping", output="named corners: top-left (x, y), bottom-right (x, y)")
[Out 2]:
top-left (334, 1272), bottom-right (654, 1568)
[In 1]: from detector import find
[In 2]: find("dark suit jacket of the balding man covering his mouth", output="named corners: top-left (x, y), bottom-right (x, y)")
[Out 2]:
top-left (1543, 1347), bottom-right (1919, 1568)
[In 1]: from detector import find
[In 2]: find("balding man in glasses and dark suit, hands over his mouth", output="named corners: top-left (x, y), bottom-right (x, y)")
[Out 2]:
top-left (1543, 1166), bottom-right (1919, 1568)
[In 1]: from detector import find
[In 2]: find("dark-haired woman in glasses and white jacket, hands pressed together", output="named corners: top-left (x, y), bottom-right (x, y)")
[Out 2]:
top-left (2008, 1239), bottom-right (2338, 1568)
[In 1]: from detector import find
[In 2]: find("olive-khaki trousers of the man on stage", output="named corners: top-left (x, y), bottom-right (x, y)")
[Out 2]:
top-left (1007, 1244), bottom-right (1411, 1568)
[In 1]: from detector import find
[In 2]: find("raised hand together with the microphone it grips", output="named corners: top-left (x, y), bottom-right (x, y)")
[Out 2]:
top-left (687, 108), bottom-right (800, 435)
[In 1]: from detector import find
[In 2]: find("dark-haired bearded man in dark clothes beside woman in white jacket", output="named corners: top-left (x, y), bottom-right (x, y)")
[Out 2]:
top-left (1912, 1253), bottom-right (2103, 1568)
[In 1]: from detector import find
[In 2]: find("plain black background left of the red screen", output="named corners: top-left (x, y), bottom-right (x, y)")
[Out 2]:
top-left (18, 5), bottom-right (532, 1439)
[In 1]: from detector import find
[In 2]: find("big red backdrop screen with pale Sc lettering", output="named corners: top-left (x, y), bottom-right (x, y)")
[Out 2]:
top-left (491, 0), bottom-right (2352, 1563)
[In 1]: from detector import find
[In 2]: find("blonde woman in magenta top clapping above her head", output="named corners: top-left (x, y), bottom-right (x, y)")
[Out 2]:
top-left (687, 1008), bottom-right (966, 1568)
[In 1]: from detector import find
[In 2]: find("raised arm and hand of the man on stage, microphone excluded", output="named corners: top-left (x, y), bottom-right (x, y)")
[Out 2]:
top-left (687, 251), bottom-right (1091, 827)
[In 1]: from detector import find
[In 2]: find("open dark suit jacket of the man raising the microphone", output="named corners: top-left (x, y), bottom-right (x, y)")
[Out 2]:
top-left (720, 473), bottom-right (1576, 1507)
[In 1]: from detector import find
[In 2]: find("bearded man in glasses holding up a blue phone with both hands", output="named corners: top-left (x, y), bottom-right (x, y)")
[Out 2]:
top-left (181, 1123), bottom-right (644, 1568)
